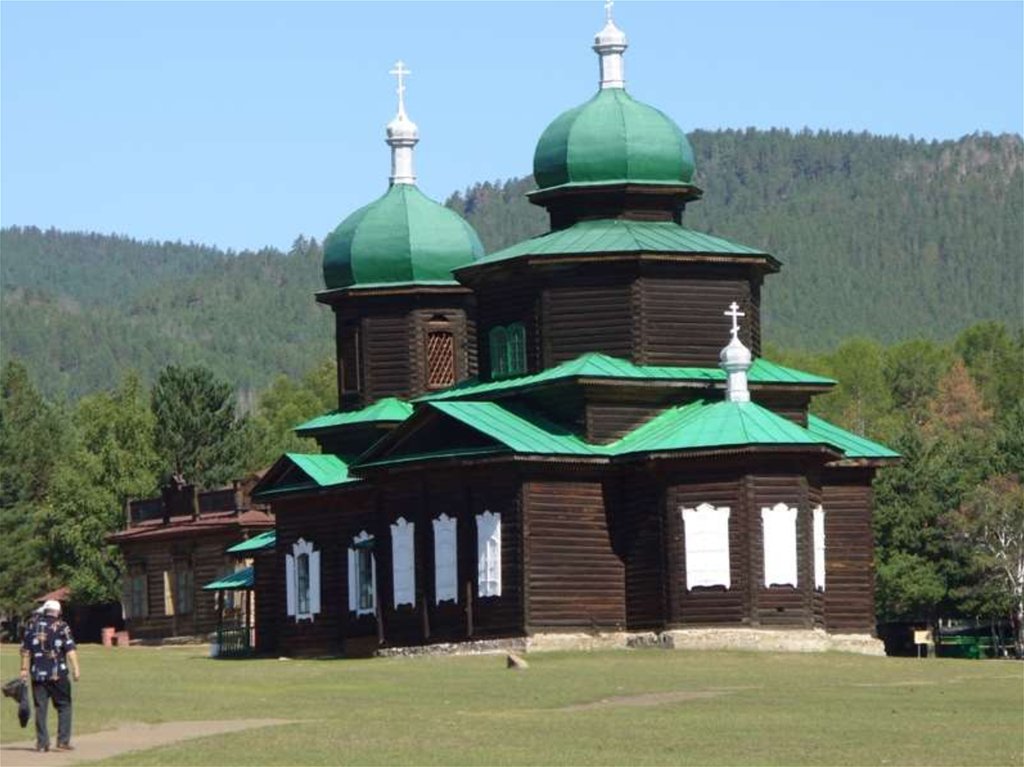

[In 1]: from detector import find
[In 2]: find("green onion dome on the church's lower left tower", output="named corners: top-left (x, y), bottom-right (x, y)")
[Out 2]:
top-left (324, 183), bottom-right (483, 290)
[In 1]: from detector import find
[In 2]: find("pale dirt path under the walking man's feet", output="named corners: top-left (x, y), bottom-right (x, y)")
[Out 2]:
top-left (0, 717), bottom-right (289, 767)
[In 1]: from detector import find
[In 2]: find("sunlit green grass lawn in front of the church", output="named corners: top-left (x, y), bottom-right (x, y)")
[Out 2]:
top-left (0, 645), bottom-right (1024, 765)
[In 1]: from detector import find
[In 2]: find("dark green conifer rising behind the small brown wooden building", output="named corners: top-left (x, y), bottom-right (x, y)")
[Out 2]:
top-left (151, 366), bottom-right (248, 487)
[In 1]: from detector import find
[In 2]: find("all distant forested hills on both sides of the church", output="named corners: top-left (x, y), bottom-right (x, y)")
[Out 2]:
top-left (0, 130), bottom-right (1024, 397)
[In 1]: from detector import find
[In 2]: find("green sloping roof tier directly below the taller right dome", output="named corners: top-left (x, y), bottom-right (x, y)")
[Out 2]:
top-left (468, 218), bottom-right (772, 270)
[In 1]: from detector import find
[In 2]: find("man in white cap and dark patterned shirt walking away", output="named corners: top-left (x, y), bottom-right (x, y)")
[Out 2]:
top-left (22, 599), bottom-right (81, 751)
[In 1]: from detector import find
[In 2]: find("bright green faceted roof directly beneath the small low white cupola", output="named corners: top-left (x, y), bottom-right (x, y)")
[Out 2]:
top-left (608, 401), bottom-right (827, 456)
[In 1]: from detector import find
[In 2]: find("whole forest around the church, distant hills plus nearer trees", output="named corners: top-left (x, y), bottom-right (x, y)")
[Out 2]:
top-left (0, 131), bottom-right (1024, 638)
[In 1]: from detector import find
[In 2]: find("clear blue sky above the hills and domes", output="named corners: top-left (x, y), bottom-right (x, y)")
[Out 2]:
top-left (0, 0), bottom-right (1024, 250)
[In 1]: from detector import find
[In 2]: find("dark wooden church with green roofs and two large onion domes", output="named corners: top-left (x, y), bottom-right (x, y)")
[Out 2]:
top-left (247, 13), bottom-right (897, 654)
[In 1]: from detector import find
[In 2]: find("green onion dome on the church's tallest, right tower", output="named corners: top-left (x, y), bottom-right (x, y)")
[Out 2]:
top-left (534, 88), bottom-right (694, 189)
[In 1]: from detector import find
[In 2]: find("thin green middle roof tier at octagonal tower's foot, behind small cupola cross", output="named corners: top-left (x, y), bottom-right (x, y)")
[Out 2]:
top-left (417, 351), bottom-right (836, 402)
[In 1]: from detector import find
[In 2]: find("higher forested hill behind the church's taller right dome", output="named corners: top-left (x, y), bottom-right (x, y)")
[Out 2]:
top-left (449, 129), bottom-right (1024, 349)
